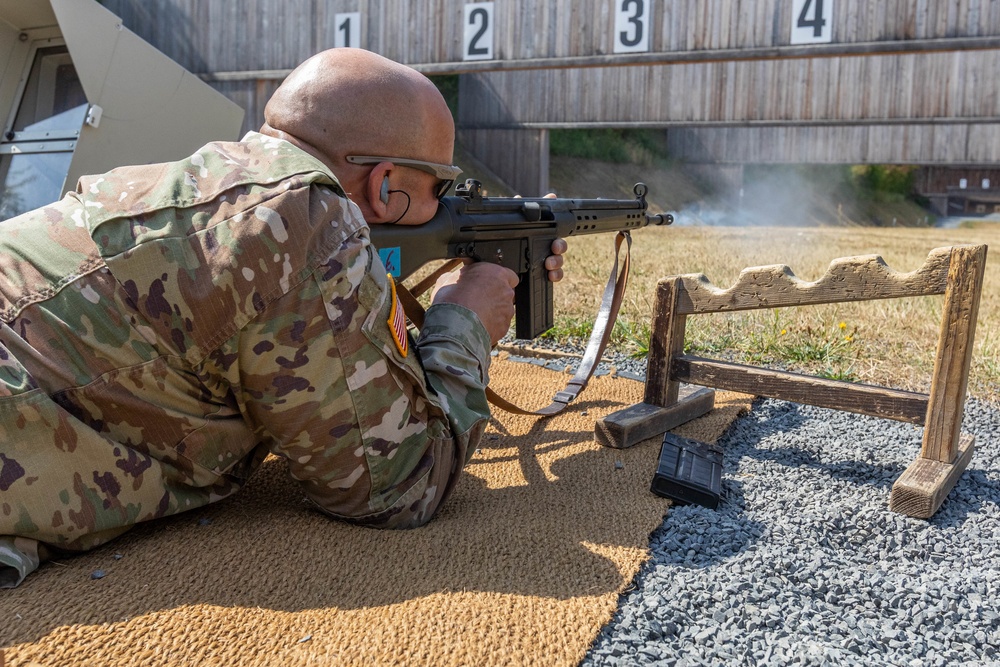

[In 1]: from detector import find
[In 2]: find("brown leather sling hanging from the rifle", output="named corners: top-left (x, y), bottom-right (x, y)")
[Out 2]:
top-left (396, 232), bottom-right (632, 417)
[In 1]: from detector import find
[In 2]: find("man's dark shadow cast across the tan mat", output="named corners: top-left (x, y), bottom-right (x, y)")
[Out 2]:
top-left (0, 402), bottom-right (668, 646)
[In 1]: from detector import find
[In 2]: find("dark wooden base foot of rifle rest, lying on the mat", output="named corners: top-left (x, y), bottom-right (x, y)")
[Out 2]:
top-left (594, 385), bottom-right (715, 449)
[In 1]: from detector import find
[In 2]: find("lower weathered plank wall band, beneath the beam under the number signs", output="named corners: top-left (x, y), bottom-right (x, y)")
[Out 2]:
top-left (459, 45), bottom-right (1000, 165)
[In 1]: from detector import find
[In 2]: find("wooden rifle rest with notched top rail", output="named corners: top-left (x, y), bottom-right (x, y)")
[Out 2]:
top-left (595, 245), bottom-right (987, 518)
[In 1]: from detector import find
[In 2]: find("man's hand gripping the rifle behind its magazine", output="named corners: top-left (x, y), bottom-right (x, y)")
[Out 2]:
top-left (431, 262), bottom-right (518, 345)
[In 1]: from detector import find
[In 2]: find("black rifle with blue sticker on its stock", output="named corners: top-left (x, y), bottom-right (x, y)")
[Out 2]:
top-left (371, 179), bottom-right (673, 338)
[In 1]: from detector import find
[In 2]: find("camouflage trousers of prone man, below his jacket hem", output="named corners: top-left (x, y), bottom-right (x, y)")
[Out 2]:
top-left (0, 350), bottom-right (267, 588)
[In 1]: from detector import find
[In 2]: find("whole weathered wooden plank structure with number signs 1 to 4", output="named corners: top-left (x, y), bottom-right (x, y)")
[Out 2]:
top-left (94, 0), bottom-right (1000, 195)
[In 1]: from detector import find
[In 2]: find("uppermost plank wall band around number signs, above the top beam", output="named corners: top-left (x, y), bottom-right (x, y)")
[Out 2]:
top-left (103, 0), bottom-right (1000, 73)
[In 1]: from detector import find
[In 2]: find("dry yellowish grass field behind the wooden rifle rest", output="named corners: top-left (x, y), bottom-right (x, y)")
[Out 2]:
top-left (555, 224), bottom-right (1000, 402)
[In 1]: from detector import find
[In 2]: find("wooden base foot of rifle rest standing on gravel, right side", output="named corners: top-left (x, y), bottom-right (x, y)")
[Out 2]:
top-left (889, 434), bottom-right (976, 519)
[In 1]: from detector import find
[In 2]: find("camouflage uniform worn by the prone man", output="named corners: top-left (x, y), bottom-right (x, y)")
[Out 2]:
top-left (0, 133), bottom-right (490, 586)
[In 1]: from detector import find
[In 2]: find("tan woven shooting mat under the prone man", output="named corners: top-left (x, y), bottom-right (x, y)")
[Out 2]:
top-left (0, 359), bottom-right (749, 667)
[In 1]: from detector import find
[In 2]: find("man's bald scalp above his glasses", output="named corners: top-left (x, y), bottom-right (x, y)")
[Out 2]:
top-left (261, 48), bottom-right (455, 171)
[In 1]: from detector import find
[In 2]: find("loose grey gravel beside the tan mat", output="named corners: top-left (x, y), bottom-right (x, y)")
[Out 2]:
top-left (504, 344), bottom-right (1000, 667)
